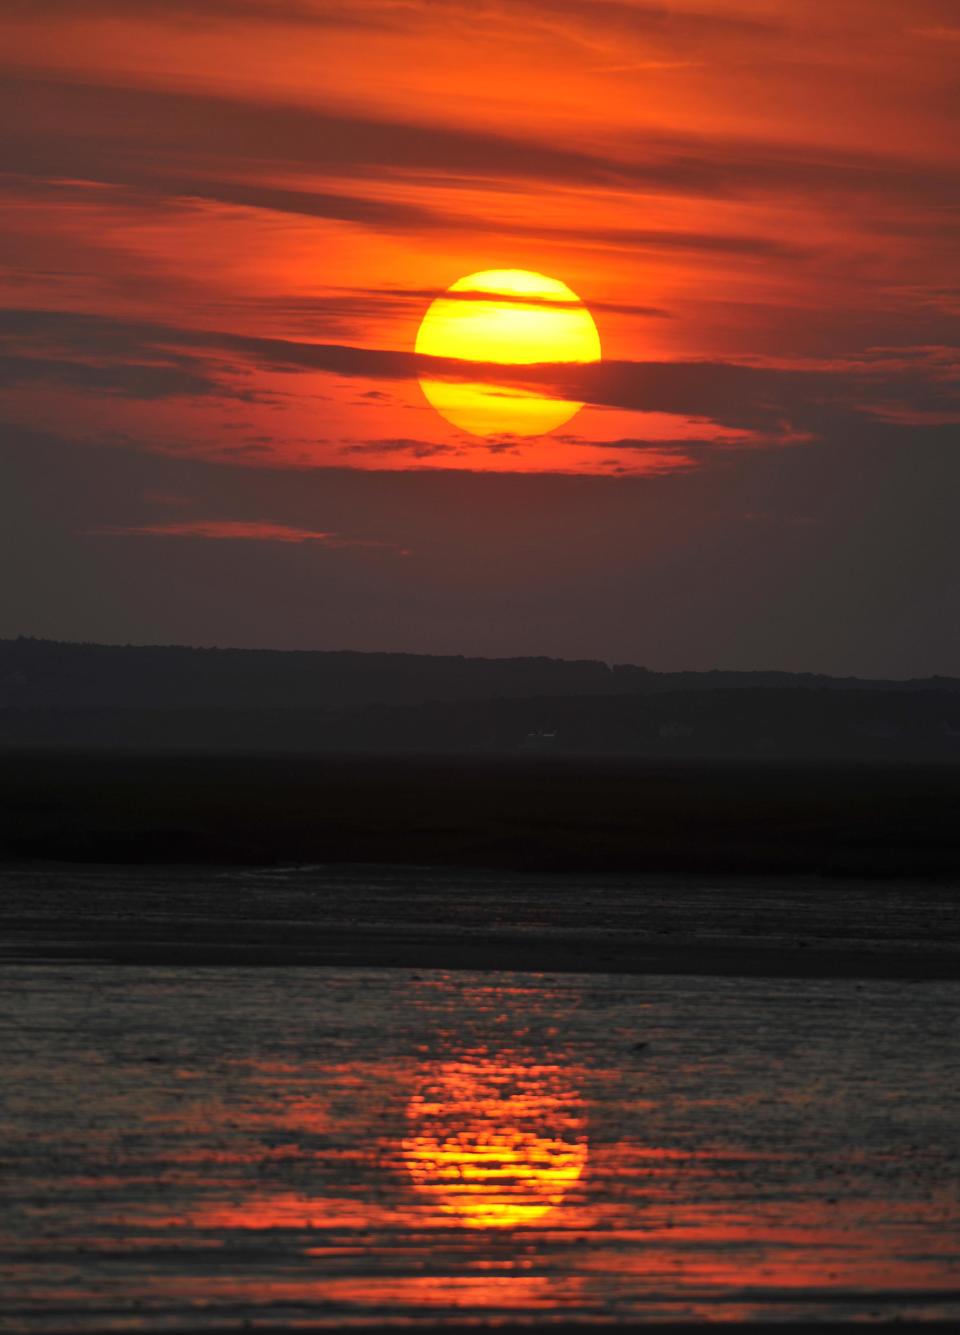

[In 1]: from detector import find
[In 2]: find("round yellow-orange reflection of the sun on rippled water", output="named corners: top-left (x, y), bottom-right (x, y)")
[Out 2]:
top-left (402, 1052), bottom-right (587, 1228)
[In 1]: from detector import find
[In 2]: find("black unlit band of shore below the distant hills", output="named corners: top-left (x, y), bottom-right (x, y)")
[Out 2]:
top-left (0, 753), bottom-right (960, 880)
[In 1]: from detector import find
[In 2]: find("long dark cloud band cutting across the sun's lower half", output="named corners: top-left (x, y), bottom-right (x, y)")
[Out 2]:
top-left (0, 311), bottom-right (960, 437)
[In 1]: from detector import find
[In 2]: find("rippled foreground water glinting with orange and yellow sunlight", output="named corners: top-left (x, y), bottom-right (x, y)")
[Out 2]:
top-left (0, 963), bottom-right (960, 1332)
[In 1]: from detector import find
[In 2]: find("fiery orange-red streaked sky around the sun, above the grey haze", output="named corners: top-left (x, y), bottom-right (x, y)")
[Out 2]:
top-left (0, 0), bottom-right (960, 667)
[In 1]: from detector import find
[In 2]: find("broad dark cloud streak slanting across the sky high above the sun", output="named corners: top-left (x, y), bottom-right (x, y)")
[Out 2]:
top-left (0, 68), bottom-right (960, 206)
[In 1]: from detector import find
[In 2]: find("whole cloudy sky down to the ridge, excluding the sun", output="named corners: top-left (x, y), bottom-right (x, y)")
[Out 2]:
top-left (0, 0), bottom-right (960, 676)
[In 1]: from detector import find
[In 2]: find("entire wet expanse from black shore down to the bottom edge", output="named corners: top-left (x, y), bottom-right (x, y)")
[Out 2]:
top-left (0, 866), bottom-right (960, 1335)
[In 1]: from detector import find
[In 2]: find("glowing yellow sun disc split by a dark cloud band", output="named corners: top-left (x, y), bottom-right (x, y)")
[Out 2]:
top-left (415, 268), bottom-right (601, 437)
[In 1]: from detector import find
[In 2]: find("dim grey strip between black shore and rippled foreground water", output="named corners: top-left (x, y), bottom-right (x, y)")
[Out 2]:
top-left (0, 865), bottom-right (960, 979)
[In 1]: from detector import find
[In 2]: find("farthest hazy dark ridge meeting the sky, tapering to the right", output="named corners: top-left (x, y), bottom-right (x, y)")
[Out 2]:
top-left (0, 638), bottom-right (960, 709)
